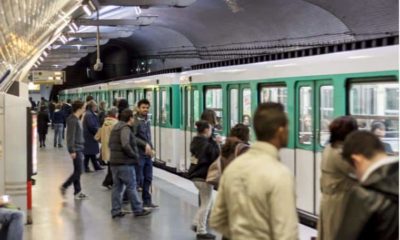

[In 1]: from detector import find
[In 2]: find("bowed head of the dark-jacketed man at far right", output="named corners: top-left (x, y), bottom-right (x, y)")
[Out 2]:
top-left (342, 131), bottom-right (386, 180)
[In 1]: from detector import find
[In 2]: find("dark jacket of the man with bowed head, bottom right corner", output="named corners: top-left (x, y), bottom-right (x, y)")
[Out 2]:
top-left (334, 158), bottom-right (399, 240)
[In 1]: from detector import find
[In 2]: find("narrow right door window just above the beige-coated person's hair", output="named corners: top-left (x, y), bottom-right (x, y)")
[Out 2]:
top-left (319, 86), bottom-right (333, 146)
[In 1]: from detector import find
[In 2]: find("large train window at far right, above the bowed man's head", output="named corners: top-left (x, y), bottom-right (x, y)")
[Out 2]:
top-left (349, 82), bottom-right (399, 154)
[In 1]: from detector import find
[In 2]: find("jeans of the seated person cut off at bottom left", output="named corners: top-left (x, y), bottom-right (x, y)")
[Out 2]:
top-left (0, 208), bottom-right (24, 240)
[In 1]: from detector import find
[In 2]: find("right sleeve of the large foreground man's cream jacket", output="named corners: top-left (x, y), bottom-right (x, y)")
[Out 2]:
top-left (266, 170), bottom-right (299, 240)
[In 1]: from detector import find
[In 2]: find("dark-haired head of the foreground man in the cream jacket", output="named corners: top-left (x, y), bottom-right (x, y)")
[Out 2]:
top-left (253, 102), bottom-right (288, 149)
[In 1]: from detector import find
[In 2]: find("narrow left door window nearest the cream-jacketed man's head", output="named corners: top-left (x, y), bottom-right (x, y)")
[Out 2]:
top-left (299, 86), bottom-right (314, 145)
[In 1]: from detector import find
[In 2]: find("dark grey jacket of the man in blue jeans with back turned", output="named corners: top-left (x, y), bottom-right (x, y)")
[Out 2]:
top-left (108, 121), bottom-right (139, 166)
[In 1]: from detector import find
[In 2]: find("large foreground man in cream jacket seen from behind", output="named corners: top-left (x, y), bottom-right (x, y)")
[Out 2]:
top-left (210, 102), bottom-right (298, 240)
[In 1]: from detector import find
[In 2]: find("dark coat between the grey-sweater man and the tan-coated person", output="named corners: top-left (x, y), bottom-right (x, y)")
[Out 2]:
top-left (82, 110), bottom-right (100, 155)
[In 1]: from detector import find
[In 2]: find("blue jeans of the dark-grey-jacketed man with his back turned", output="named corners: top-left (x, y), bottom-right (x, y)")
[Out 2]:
top-left (111, 165), bottom-right (143, 216)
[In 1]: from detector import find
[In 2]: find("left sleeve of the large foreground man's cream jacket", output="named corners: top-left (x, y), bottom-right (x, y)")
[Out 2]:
top-left (210, 175), bottom-right (230, 238)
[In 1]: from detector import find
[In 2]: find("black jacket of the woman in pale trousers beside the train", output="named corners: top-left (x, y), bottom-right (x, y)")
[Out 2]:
top-left (188, 136), bottom-right (220, 181)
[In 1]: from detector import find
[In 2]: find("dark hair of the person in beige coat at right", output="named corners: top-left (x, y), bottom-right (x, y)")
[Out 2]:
top-left (329, 116), bottom-right (358, 146)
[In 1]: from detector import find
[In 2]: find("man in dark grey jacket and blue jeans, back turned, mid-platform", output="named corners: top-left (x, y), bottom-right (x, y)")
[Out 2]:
top-left (109, 109), bottom-right (151, 218)
